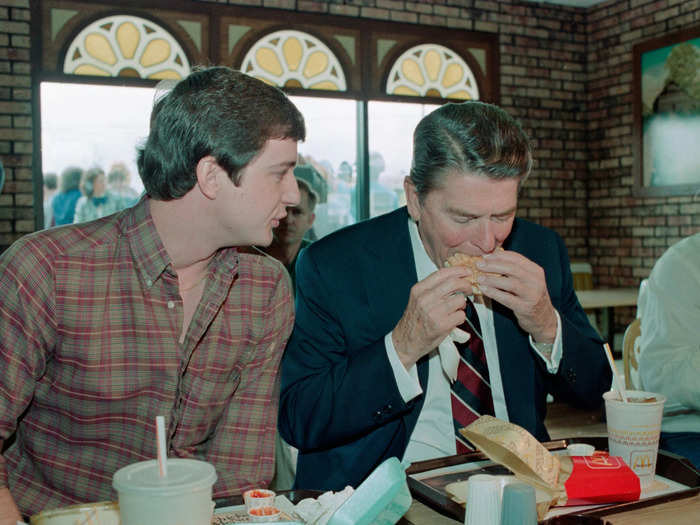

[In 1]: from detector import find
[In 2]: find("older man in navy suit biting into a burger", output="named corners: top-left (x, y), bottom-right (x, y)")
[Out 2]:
top-left (279, 102), bottom-right (610, 489)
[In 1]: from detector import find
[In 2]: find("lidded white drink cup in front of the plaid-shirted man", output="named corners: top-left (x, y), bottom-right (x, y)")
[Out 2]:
top-left (112, 458), bottom-right (216, 525)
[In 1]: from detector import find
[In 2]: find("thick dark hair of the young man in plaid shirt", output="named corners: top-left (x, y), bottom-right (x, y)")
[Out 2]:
top-left (137, 67), bottom-right (306, 200)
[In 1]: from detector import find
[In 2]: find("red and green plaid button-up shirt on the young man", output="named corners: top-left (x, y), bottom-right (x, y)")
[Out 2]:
top-left (0, 199), bottom-right (294, 514)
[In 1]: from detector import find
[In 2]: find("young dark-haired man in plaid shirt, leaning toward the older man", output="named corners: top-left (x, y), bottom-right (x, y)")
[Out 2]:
top-left (0, 67), bottom-right (305, 525)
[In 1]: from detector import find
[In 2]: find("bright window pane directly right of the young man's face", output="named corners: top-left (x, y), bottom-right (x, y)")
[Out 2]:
top-left (290, 97), bottom-right (358, 240)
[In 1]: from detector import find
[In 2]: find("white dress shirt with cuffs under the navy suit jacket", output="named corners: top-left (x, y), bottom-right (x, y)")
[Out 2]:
top-left (384, 218), bottom-right (562, 462)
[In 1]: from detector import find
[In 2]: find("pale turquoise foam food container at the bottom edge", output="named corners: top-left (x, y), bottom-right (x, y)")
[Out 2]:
top-left (328, 458), bottom-right (413, 525)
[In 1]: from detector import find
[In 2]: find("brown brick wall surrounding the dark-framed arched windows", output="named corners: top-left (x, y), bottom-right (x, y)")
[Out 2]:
top-left (0, 0), bottom-right (700, 322)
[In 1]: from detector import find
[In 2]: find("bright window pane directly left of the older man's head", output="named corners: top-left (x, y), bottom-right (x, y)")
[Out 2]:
top-left (368, 101), bottom-right (439, 217)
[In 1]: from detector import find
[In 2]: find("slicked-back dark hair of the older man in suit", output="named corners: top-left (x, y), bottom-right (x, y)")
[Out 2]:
top-left (410, 101), bottom-right (532, 199)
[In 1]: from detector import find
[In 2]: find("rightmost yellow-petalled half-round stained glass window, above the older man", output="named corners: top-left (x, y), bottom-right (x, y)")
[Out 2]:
top-left (386, 44), bottom-right (479, 100)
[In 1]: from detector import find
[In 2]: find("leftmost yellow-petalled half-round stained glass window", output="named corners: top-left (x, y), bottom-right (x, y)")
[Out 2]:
top-left (63, 15), bottom-right (190, 79)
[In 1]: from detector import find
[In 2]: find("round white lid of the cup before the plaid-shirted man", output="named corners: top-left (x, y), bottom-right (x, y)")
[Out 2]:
top-left (112, 458), bottom-right (216, 496)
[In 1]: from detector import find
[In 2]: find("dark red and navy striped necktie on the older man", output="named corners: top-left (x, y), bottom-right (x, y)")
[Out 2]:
top-left (450, 299), bottom-right (494, 454)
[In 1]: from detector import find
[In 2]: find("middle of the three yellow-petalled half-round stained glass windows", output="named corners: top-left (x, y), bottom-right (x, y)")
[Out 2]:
top-left (241, 30), bottom-right (347, 91)
